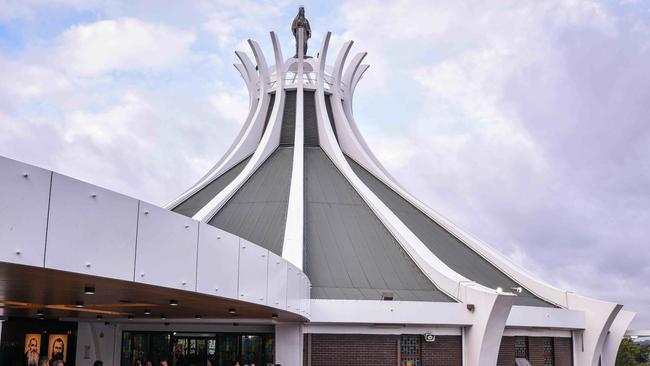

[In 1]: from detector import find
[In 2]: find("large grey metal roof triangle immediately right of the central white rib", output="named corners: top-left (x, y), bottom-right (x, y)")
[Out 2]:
top-left (305, 147), bottom-right (453, 302)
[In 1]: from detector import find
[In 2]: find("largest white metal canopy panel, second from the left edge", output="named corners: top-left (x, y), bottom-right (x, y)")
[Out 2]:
top-left (45, 173), bottom-right (138, 280)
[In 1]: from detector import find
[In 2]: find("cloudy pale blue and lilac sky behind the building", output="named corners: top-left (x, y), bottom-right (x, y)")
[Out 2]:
top-left (0, 0), bottom-right (650, 329)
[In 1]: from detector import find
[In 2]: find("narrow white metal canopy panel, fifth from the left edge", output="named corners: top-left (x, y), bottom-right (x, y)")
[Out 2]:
top-left (239, 239), bottom-right (269, 305)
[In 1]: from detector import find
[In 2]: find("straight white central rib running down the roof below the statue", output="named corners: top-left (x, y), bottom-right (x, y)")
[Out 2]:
top-left (278, 28), bottom-right (305, 270)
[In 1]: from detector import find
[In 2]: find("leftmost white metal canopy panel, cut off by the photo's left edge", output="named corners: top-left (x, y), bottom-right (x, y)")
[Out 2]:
top-left (0, 157), bottom-right (52, 266)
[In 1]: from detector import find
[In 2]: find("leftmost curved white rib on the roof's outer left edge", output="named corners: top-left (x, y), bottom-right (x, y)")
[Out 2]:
top-left (165, 51), bottom-right (269, 210)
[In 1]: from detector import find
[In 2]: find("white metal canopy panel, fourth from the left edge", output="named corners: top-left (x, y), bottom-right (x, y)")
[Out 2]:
top-left (196, 223), bottom-right (239, 299)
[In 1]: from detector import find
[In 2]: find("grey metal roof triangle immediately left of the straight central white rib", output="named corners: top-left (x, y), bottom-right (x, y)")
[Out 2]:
top-left (209, 146), bottom-right (293, 255)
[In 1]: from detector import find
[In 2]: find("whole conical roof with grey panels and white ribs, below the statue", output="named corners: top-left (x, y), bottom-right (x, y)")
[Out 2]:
top-left (168, 33), bottom-right (553, 306)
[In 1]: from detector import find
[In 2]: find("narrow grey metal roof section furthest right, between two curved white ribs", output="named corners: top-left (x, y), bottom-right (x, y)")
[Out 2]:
top-left (347, 157), bottom-right (553, 306)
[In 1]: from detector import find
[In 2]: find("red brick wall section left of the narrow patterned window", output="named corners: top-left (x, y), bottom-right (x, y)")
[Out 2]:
top-left (304, 334), bottom-right (399, 366)
